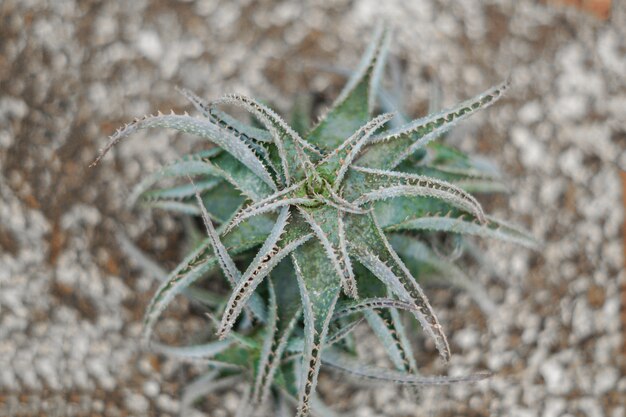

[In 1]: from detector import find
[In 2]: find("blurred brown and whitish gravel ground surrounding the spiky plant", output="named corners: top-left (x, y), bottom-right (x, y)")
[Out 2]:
top-left (0, 0), bottom-right (626, 417)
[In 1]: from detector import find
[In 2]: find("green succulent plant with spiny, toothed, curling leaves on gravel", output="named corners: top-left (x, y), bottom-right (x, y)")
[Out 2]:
top-left (94, 29), bottom-right (535, 416)
